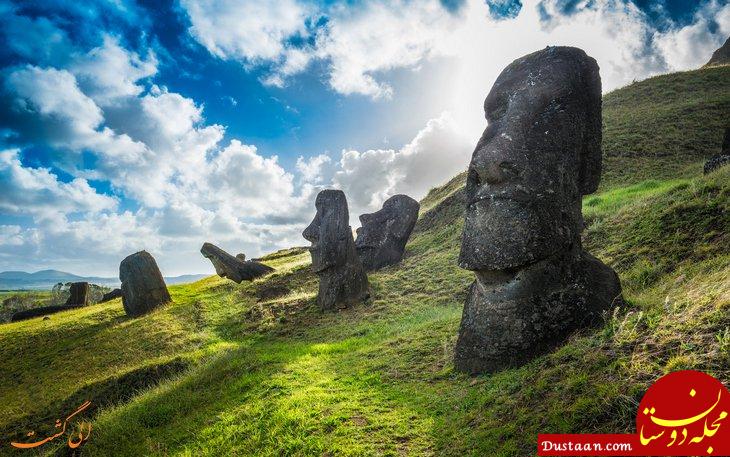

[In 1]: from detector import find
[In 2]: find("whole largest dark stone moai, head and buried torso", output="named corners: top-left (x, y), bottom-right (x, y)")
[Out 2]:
top-left (454, 47), bottom-right (621, 373)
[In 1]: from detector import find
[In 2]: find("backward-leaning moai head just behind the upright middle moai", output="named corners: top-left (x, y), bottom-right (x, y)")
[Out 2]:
top-left (355, 194), bottom-right (421, 271)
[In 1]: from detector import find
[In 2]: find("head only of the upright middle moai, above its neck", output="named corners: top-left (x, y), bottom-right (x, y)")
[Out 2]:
top-left (302, 189), bottom-right (352, 272)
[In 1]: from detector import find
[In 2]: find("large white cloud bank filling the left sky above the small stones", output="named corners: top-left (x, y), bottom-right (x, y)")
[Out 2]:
top-left (0, 40), bottom-right (314, 273)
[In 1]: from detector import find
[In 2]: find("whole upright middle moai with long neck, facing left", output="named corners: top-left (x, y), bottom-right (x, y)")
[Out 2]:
top-left (302, 189), bottom-right (368, 310)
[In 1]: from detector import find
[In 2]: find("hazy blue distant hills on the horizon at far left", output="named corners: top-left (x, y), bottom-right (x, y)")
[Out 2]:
top-left (0, 270), bottom-right (208, 290)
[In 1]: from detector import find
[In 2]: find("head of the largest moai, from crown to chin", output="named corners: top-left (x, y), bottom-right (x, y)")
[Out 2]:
top-left (459, 47), bottom-right (601, 271)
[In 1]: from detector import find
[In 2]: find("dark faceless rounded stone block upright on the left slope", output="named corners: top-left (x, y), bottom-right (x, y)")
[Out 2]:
top-left (119, 251), bottom-right (171, 317)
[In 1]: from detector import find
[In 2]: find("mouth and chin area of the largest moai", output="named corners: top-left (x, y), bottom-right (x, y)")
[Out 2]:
top-left (459, 200), bottom-right (568, 270)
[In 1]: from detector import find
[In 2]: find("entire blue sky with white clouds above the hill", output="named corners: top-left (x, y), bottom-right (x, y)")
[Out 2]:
top-left (0, 0), bottom-right (730, 275)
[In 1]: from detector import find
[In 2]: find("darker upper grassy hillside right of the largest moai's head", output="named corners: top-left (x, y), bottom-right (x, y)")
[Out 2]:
top-left (601, 65), bottom-right (730, 189)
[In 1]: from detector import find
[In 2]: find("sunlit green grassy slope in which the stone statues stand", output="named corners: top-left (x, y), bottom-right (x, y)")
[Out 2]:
top-left (0, 67), bottom-right (730, 456)
